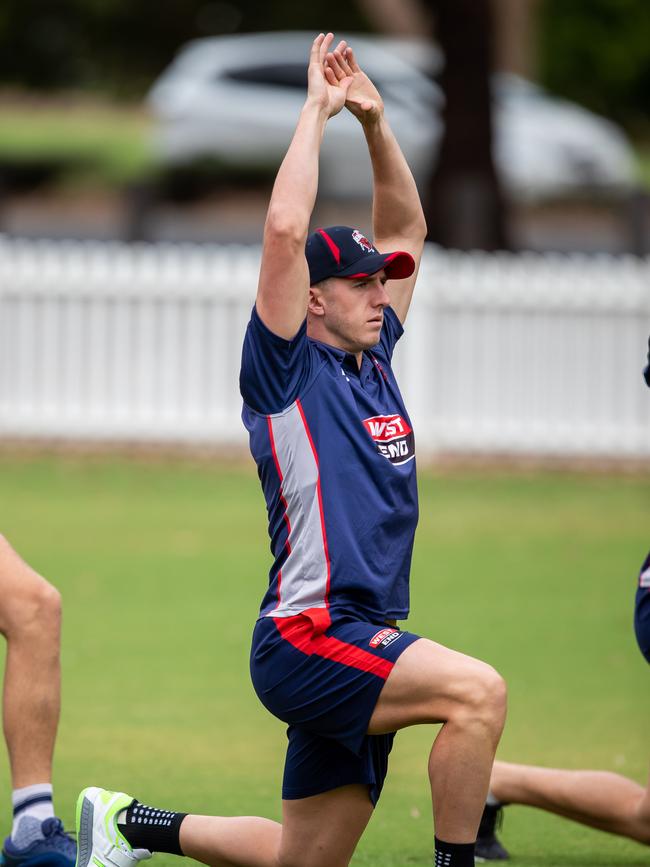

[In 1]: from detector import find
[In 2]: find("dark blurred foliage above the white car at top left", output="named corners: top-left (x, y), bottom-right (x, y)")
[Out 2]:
top-left (0, 0), bottom-right (368, 96)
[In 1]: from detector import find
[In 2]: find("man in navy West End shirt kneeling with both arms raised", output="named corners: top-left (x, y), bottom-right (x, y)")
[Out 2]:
top-left (73, 34), bottom-right (505, 867)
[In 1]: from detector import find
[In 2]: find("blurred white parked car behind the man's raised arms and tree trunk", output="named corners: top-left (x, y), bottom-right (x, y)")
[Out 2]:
top-left (149, 32), bottom-right (634, 199)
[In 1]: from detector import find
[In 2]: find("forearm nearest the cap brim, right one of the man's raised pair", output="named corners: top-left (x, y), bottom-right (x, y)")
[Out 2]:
top-left (363, 117), bottom-right (426, 239)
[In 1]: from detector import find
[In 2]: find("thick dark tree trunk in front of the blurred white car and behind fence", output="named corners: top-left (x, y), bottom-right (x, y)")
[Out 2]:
top-left (423, 0), bottom-right (509, 250)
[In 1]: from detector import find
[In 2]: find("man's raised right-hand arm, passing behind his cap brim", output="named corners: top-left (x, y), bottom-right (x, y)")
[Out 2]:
top-left (325, 44), bottom-right (427, 322)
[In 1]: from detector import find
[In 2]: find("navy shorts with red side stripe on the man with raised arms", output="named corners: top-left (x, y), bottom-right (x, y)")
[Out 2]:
top-left (251, 608), bottom-right (419, 804)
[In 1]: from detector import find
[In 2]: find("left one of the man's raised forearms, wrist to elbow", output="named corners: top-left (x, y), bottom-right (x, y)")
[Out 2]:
top-left (267, 101), bottom-right (327, 235)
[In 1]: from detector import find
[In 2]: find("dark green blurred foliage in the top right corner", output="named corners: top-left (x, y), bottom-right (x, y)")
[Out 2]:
top-left (539, 0), bottom-right (650, 134)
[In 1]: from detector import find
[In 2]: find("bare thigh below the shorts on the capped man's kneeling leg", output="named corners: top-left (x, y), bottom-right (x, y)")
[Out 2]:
top-left (280, 785), bottom-right (373, 867)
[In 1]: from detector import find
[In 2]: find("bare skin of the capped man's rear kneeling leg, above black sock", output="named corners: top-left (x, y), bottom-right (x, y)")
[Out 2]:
top-left (180, 785), bottom-right (373, 867)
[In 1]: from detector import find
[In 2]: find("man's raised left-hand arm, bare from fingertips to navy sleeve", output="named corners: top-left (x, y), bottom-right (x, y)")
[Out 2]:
top-left (256, 33), bottom-right (352, 340)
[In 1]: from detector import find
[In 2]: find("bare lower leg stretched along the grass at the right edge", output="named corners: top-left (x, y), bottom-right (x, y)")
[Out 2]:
top-left (490, 762), bottom-right (650, 845)
